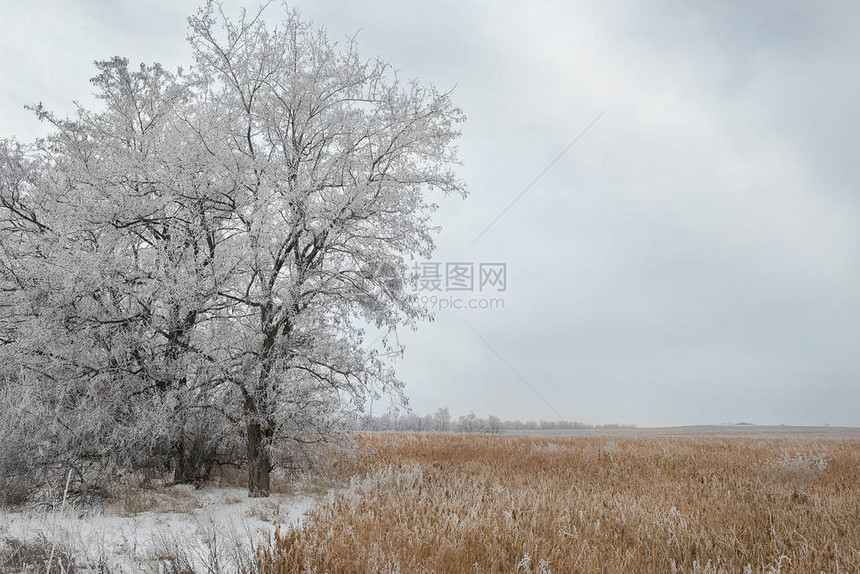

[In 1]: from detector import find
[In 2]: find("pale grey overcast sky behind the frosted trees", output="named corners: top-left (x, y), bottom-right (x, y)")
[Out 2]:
top-left (0, 0), bottom-right (860, 426)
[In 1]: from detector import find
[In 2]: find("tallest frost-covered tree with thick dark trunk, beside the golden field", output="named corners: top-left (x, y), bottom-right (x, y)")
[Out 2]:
top-left (181, 3), bottom-right (463, 495)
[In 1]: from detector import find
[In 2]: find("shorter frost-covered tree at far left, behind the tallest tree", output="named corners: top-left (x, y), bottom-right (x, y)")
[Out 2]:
top-left (0, 58), bottom-right (230, 486)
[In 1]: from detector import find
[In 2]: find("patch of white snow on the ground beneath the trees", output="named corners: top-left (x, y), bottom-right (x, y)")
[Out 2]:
top-left (0, 486), bottom-right (318, 572)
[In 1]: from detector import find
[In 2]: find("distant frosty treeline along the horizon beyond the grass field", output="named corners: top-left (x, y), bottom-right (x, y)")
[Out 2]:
top-left (354, 407), bottom-right (636, 434)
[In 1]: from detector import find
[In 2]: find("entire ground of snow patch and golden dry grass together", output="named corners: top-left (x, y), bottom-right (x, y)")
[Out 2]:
top-left (0, 427), bottom-right (860, 574)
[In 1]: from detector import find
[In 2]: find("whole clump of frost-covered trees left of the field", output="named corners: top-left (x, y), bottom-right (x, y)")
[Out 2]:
top-left (0, 2), bottom-right (464, 496)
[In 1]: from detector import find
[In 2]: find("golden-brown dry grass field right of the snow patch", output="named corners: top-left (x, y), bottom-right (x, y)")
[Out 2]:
top-left (260, 434), bottom-right (860, 574)
